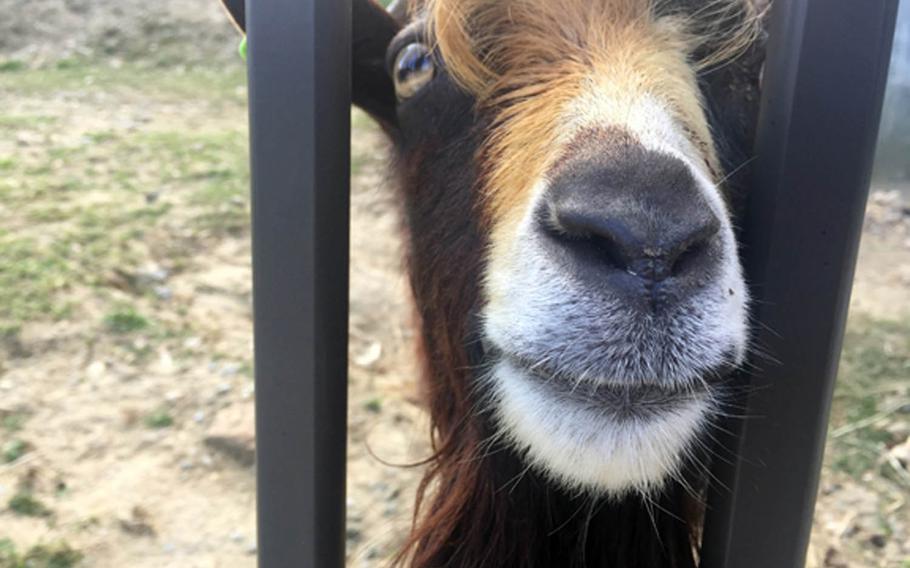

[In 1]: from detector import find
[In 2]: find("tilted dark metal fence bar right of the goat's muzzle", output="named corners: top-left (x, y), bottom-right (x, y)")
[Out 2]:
top-left (702, 0), bottom-right (898, 568)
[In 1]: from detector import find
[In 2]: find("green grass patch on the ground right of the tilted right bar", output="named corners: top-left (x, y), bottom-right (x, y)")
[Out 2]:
top-left (828, 317), bottom-right (910, 478)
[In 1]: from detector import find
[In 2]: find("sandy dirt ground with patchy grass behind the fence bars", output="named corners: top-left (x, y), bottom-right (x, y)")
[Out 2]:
top-left (0, 0), bottom-right (910, 568)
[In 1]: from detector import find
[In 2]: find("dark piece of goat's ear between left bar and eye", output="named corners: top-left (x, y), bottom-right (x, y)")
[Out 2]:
top-left (351, 0), bottom-right (401, 128)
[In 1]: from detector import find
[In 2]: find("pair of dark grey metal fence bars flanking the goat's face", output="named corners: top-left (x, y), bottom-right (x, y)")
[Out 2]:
top-left (246, 0), bottom-right (897, 568)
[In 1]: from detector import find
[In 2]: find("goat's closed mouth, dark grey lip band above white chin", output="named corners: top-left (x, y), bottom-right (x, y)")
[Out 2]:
top-left (502, 354), bottom-right (733, 420)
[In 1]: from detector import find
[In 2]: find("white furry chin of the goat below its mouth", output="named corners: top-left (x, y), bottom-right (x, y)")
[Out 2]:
top-left (485, 361), bottom-right (714, 498)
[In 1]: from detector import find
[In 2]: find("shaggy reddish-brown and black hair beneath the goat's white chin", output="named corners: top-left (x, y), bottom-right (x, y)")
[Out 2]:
top-left (395, 309), bottom-right (706, 568)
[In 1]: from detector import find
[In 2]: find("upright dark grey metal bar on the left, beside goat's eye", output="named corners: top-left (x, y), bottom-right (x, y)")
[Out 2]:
top-left (246, 0), bottom-right (351, 568)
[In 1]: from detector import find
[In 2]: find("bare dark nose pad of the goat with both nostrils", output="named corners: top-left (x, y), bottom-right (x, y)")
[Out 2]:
top-left (553, 206), bottom-right (720, 282)
